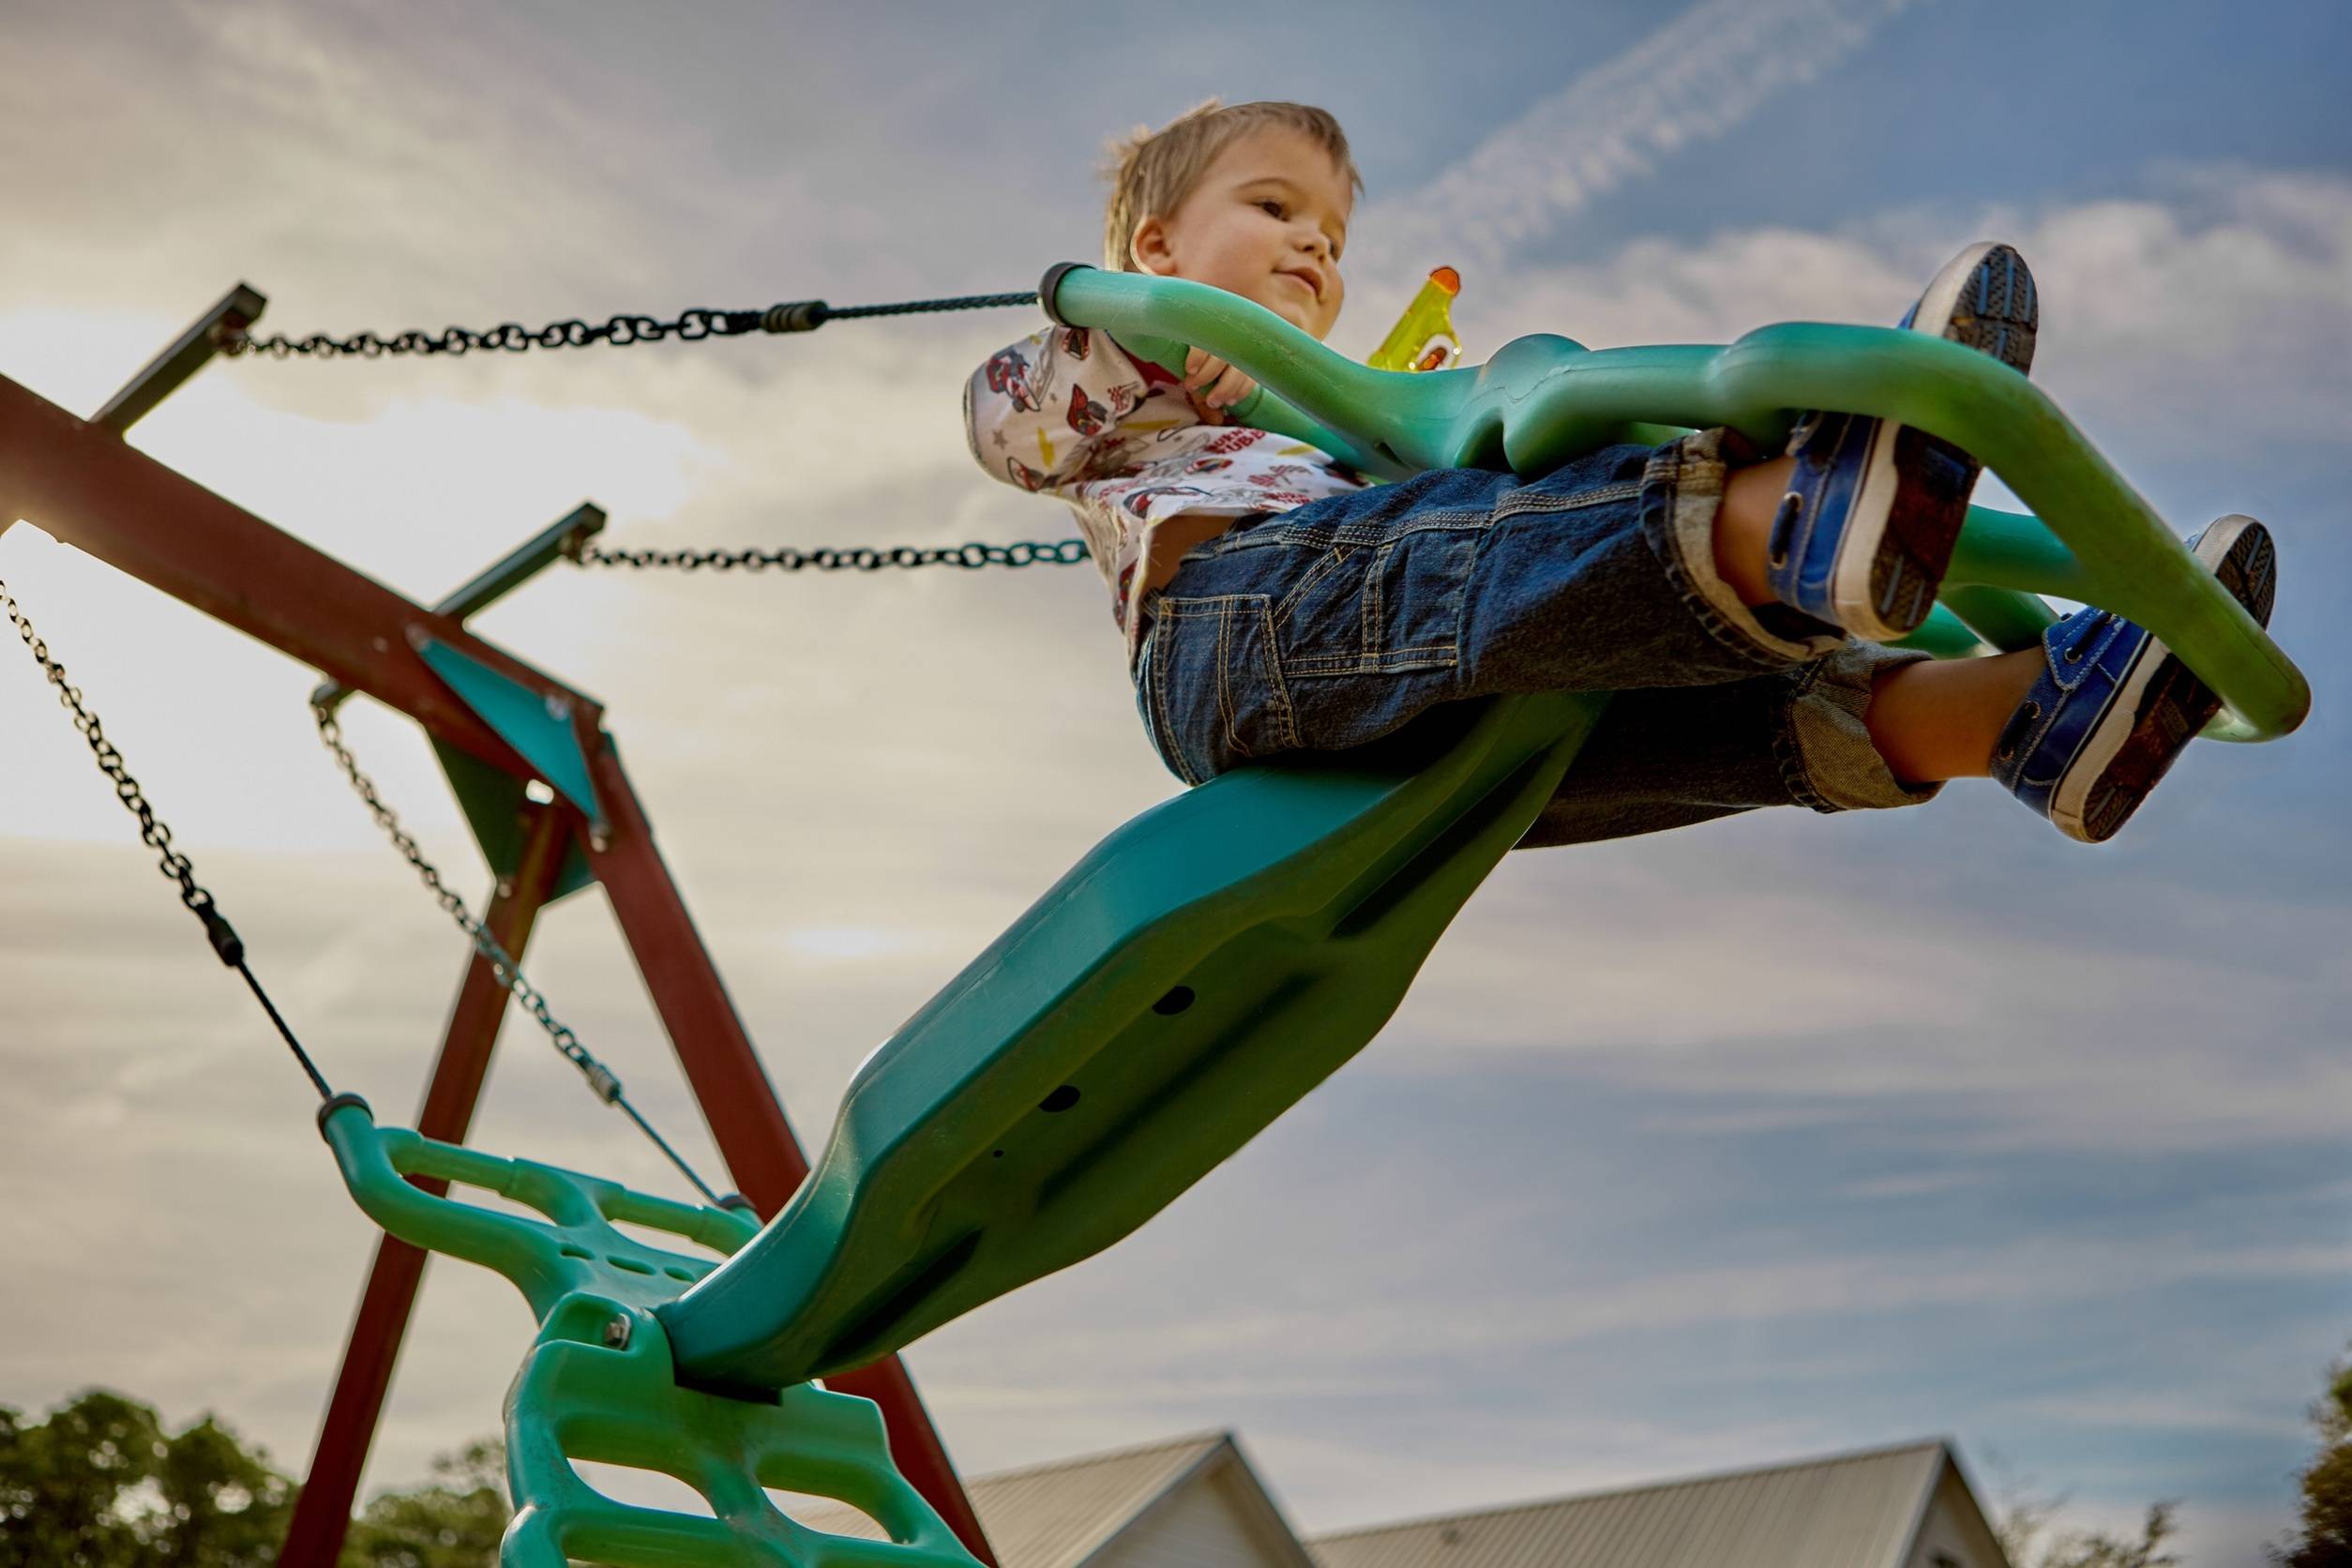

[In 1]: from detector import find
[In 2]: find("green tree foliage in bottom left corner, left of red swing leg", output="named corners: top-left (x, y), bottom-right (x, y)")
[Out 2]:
top-left (0, 1389), bottom-right (294, 1568)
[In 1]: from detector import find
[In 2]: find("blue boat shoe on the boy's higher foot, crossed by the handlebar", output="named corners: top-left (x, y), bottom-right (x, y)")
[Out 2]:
top-left (1767, 242), bottom-right (2042, 641)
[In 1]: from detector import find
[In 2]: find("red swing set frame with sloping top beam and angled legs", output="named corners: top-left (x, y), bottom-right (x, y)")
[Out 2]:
top-left (0, 284), bottom-right (995, 1568)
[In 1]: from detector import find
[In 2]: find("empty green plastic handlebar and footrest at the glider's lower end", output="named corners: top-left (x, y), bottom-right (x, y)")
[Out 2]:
top-left (320, 1095), bottom-right (978, 1568)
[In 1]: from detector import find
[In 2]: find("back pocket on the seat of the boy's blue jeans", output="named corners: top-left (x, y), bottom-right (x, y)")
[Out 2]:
top-left (1148, 593), bottom-right (1298, 785)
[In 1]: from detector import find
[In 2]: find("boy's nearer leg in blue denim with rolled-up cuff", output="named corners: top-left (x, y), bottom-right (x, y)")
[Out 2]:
top-left (1136, 430), bottom-right (1844, 783)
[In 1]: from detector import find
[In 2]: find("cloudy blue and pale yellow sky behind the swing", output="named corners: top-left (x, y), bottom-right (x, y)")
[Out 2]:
top-left (0, 0), bottom-right (2352, 1568)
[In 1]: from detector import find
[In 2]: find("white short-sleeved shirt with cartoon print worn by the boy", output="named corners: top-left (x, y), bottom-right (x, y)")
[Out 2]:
top-left (964, 326), bottom-right (1364, 668)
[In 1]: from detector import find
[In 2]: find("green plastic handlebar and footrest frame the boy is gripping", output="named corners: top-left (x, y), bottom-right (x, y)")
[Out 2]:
top-left (1045, 268), bottom-right (2312, 741)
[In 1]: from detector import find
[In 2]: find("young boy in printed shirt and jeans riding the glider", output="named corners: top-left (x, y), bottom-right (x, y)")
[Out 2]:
top-left (964, 98), bottom-right (2272, 846)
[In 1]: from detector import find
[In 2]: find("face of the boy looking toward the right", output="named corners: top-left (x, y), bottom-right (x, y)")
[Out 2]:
top-left (1131, 127), bottom-right (1355, 339)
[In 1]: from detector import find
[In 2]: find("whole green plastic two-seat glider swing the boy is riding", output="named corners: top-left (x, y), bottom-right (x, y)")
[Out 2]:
top-left (320, 268), bottom-right (2310, 1568)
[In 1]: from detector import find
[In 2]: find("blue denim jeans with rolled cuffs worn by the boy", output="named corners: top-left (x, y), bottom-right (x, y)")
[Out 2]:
top-left (1136, 430), bottom-right (1936, 849)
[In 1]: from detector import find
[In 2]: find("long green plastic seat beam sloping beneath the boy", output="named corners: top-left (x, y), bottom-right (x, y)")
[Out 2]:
top-left (658, 693), bottom-right (1606, 1389)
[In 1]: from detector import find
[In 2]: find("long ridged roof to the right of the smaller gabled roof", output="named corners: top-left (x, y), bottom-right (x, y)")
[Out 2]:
top-left (1307, 1441), bottom-right (1952, 1568)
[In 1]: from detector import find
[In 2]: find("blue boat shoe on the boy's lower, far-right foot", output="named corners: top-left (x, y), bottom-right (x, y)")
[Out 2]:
top-left (1992, 512), bottom-right (2277, 844)
